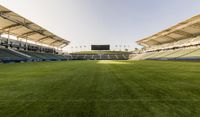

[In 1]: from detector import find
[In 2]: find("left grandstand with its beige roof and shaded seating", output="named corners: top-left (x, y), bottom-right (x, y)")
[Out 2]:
top-left (0, 6), bottom-right (69, 63)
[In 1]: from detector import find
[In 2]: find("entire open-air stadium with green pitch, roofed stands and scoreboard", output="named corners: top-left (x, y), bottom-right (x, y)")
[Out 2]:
top-left (0, 0), bottom-right (200, 117)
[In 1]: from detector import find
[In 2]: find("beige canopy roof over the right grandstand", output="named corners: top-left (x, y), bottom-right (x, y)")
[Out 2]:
top-left (137, 15), bottom-right (200, 46)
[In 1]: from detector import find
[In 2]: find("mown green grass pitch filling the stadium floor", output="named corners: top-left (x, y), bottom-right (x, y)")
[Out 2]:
top-left (0, 61), bottom-right (200, 117)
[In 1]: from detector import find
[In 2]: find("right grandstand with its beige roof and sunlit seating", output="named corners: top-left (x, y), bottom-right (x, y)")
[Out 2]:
top-left (130, 15), bottom-right (200, 60)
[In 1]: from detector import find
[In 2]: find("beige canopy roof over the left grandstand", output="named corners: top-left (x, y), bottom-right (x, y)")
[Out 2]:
top-left (0, 5), bottom-right (69, 47)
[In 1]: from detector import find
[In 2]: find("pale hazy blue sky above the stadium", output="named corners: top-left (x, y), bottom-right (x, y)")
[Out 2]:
top-left (0, 0), bottom-right (200, 51)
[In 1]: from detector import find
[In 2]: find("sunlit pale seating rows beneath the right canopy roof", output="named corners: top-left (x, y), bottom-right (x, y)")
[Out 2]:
top-left (131, 47), bottom-right (200, 60)
